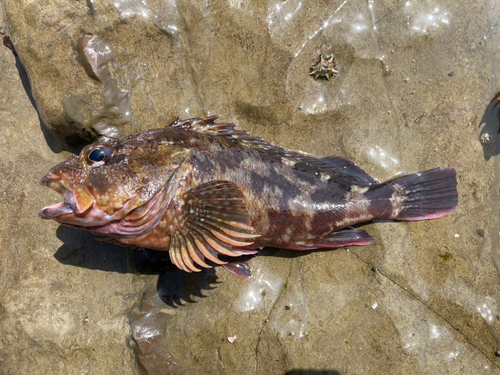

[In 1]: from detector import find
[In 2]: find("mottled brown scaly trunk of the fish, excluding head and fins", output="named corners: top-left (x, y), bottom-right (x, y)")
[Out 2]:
top-left (116, 128), bottom-right (368, 250)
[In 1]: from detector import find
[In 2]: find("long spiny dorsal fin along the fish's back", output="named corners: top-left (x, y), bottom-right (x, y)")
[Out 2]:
top-left (167, 116), bottom-right (377, 185)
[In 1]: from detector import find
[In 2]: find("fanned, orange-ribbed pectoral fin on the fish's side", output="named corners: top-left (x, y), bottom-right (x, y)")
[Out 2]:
top-left (169, 181), bottom-right (259, 272)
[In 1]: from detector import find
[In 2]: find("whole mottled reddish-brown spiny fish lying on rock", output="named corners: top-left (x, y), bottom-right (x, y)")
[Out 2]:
top-left (39, 116), bottom-right (458, 277)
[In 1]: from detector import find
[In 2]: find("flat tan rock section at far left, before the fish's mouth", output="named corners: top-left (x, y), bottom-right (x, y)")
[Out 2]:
top-left (0, 19), bottom-right (148, 374)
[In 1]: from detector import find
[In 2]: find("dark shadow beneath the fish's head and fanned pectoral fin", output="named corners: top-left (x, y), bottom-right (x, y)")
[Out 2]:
top-left (54, 225), bottom-right (218, 307)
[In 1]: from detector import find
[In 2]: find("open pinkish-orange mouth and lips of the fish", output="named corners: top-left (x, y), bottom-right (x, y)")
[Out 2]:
top-left (38, 175), bottom-right (92, 219)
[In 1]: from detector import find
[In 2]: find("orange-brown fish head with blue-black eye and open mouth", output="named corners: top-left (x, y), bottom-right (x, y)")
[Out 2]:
top-left (39, 136), bottom-right (189, 230)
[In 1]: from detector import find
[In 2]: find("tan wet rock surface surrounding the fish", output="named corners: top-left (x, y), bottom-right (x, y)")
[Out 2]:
top-left (0, 0), bottom-right (500, 374)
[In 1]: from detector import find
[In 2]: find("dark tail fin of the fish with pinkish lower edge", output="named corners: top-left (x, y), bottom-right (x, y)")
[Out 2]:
top-left (389, 168), bottom-right (458, 221)
